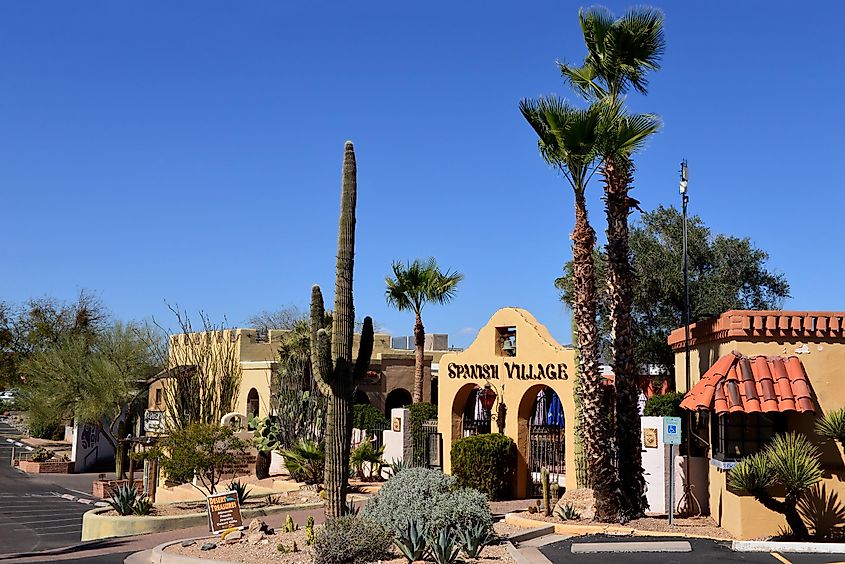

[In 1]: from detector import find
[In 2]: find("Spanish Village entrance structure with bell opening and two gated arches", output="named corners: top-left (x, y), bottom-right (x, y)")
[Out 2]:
top-left (437, 307), bottom-right (576, 497)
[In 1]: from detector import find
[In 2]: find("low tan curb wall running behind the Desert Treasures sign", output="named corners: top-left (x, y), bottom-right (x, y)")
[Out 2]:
top-left (82, 502), bottom-right (323, 541)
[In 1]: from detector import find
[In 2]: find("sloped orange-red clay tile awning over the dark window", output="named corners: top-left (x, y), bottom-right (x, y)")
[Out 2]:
top-left (681, 352), bottom-right (815, 415)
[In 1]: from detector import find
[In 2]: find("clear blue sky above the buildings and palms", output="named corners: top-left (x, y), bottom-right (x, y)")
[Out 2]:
top-left (0, 0), bottom-right (845, 345)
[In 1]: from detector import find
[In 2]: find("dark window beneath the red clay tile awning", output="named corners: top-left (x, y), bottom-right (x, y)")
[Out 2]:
top-left (712, 413), bottom-right (786, 461)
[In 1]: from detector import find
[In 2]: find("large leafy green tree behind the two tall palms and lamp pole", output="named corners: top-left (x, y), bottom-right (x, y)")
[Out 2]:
top-left (555, 206), bottom-right (789, 374)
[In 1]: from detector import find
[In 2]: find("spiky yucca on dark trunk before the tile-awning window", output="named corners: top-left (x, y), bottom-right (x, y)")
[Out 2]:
top-left (728, 433), bottom-right (822, 540)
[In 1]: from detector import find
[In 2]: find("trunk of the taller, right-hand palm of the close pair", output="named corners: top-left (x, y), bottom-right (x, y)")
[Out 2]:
top-left (602, 155), bottom-right (648, 521)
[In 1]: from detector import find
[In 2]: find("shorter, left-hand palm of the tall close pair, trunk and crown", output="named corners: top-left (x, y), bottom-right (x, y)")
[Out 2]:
top-left (519, 97), bottom-right (621, 521)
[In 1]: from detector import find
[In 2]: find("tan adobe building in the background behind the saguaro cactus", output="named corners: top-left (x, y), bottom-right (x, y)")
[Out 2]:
top-left (147, 329), bottom-right (448, 416)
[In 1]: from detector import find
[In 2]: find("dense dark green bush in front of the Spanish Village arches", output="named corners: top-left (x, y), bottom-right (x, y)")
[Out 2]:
top-left (452, 433), bottom-right (516, 499)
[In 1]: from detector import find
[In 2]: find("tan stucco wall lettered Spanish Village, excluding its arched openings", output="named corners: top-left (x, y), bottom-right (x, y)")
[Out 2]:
top-left (437, 307), bottom-right (575, 497)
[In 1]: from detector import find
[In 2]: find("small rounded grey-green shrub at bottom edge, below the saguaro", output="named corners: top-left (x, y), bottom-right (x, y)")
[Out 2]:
top-left (314, 515), bottom-right (393, 564)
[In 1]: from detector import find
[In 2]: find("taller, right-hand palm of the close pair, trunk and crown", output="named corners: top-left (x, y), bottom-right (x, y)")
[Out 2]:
top-left (560, 8), bottom-right (665, 520)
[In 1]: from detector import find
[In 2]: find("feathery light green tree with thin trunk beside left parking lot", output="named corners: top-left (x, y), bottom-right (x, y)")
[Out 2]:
top-left (21, 323), bottom-right (158, 475)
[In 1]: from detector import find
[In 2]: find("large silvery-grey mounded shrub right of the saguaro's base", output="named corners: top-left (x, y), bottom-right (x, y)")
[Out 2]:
top-left (364, 468), bottom-right (493, 536)
